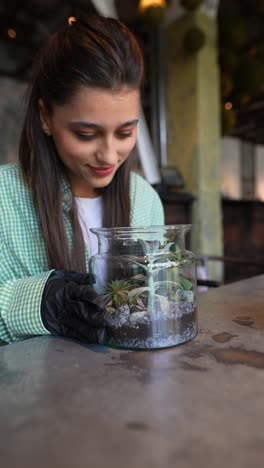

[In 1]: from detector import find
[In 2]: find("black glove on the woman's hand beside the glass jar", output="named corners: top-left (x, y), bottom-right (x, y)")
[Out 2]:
top-left (41, 270), bottom-right (105, 343)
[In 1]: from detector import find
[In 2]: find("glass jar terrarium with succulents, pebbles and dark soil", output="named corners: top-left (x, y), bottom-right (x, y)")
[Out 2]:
top-left (90, 225), bottom-right (197, 349)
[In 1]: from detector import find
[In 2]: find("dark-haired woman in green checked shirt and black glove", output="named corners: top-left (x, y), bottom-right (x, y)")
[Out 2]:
top-left (0, 16), bottom-right (164, 343)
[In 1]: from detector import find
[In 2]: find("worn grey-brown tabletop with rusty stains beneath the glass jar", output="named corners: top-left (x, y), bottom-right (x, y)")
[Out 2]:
top-left (0, 275), bottom-right (264, 468)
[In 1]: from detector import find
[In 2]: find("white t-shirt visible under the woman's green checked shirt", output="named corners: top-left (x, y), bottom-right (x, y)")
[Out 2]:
top-left (75, 197), bottom-right (103, 257)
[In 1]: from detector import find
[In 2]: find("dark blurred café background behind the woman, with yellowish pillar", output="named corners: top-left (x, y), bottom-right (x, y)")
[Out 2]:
top-left (0, 0), bottom-right (264, 286)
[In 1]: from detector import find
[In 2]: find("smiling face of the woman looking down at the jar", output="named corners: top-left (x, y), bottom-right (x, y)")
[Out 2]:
top-left (39, 87), bottom-right (140, 198)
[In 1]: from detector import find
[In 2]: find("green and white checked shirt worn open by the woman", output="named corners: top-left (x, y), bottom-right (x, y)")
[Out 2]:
top-left (0, 164), bottom-right (164, 343)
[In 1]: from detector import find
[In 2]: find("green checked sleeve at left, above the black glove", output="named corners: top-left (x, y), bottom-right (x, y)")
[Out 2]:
top-left (0, 165), bottom-right (51, 343)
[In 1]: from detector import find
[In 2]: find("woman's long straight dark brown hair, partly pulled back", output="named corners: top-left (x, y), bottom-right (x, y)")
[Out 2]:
top-left (19, 15), bottom-right (143, 271)
